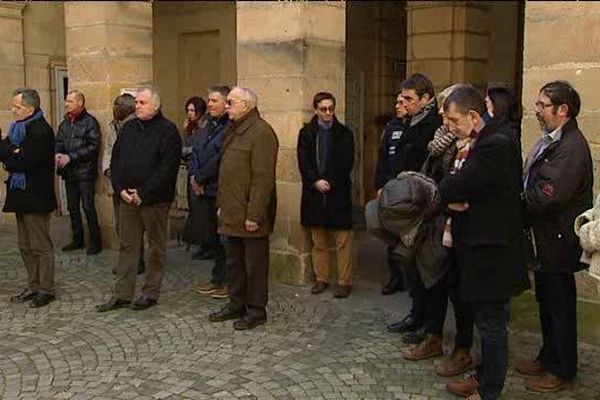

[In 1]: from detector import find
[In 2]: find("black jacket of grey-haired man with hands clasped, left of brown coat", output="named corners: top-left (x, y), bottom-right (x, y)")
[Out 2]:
top-left (110, 112), bottom-right (181, 206)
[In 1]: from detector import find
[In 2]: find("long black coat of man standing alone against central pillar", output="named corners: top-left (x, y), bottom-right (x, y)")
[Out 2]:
top-left (297, 116), bottom-right (354, 229)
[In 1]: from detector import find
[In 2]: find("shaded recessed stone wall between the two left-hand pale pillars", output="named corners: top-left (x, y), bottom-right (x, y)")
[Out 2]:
top-left (153, 1), bottom-right (237, 127)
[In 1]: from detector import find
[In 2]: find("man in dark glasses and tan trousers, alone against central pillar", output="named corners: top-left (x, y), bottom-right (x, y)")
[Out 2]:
top-left (297, 92), bottom-right (354, 298)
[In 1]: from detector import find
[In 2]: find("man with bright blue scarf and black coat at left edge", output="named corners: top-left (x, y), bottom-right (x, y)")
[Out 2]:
top-left (0, 89), bottom-right (56, 308)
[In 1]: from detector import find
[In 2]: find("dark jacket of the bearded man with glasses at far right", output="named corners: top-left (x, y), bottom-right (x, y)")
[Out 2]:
top-left (523, 120), bottom-right (594, 273)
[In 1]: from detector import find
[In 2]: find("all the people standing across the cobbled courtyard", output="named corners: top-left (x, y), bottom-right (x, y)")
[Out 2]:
top-left (0, 74), bottom-right (592, 400)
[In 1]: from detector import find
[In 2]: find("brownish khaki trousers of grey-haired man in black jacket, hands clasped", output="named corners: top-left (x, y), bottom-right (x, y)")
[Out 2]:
top-left (115, 201), bottom-right (169, 301)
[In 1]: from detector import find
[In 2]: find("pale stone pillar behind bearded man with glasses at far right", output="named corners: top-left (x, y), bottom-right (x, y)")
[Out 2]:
top-left (522, 1), bottom-right (600, 300)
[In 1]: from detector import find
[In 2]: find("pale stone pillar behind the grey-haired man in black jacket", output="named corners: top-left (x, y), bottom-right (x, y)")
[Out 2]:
top-left (64, 1), bottom-right (152, 245)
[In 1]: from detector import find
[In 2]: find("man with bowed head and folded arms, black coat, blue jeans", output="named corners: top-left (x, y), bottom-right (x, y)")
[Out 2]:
top-left (440, 86), bottom-right (524, 400)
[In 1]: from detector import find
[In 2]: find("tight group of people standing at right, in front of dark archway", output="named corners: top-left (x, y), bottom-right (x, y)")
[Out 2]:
top-left (368, 74), bottom-right (593, 400)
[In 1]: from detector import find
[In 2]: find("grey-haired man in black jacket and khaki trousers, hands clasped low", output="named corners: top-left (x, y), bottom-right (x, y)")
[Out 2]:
top-left (96, 88), bottom-right (181, 312)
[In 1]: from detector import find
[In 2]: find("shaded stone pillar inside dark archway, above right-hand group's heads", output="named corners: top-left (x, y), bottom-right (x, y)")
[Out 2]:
top-left (406, 1), bottom-right (490, 92)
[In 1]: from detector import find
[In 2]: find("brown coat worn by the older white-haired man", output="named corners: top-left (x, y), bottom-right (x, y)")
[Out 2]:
top-left (217, 109), bottom-right (279, 237)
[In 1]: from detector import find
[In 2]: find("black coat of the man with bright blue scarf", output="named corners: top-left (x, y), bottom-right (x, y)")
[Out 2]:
top-left (0, 118), bottom-right (56, 214)
